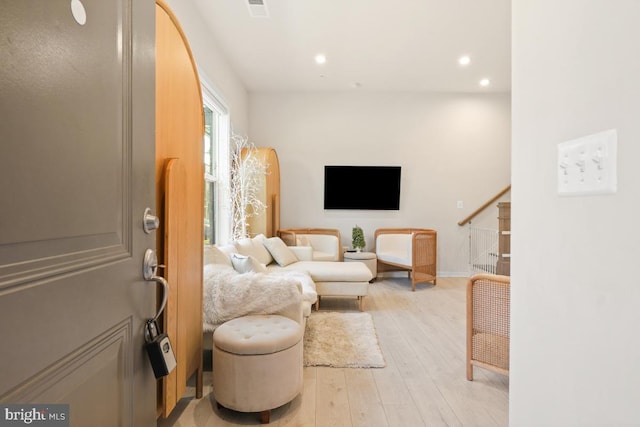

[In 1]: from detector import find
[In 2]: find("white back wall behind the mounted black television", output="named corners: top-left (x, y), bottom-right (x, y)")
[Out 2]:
top-left (249, 92), bottom-right (511, 275)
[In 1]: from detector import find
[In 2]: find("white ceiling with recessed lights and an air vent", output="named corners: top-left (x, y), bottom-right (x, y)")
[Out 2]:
top-left (192, 0), bottom-right (511, 92)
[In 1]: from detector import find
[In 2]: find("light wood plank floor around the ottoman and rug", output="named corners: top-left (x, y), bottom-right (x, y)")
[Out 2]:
top-left (158, 277), bottom-right (509, 427)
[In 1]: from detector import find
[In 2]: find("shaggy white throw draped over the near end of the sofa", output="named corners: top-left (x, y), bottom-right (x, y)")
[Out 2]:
top-left (203, 265), bottom-right (302, 331)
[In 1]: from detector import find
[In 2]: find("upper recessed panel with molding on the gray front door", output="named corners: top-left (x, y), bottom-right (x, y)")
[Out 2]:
top-left (0, 0), bottom-right (135, 294)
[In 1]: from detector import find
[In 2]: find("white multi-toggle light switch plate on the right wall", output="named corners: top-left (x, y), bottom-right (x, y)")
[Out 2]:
top-left (558, 129), bottom-right (618, 196)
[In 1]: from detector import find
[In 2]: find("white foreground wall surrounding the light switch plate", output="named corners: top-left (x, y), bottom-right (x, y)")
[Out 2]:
top-left (510, 0), bottom-right (640, 426)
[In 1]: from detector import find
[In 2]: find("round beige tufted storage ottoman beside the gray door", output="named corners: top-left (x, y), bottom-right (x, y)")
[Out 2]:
top-left (213, 315), bottom-right (304, 423)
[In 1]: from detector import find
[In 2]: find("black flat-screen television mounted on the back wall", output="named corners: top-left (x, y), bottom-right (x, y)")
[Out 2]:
top-left (324, 166), bottom-right (400, 210)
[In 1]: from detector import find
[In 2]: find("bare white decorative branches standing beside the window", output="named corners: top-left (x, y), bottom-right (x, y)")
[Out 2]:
top-left (231, 134), bottom-right (269, 240)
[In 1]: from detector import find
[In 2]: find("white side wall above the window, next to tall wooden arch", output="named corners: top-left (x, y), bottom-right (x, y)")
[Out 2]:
top-left (166, 0), bottom-right (249, 135)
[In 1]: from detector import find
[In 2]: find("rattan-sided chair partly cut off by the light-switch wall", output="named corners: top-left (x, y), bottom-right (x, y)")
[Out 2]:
top-left (467, 274), bottom-right (511, 381)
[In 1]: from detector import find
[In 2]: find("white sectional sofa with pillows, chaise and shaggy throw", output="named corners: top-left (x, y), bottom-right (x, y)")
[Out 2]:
top-left (204, 235), bottom-right (372, 331)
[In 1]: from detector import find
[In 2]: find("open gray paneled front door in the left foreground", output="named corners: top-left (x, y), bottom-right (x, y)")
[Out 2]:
top-left (0, 0), bottom-right (156, 426)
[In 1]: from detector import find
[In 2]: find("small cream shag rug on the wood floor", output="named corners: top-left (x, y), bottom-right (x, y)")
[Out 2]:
top-left (304, 312), bottom-right (386, 368)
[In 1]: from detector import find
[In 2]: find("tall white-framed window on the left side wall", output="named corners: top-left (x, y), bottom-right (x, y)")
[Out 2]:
top-left (202, 83), bottom-right (231, 245)
